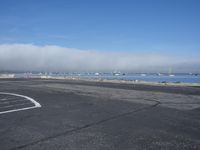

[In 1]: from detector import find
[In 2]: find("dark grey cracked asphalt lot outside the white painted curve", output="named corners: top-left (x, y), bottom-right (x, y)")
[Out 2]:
top-left (0, 79), bottom-right (200, 150)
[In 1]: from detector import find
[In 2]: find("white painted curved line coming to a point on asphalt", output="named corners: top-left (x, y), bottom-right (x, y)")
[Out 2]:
top-left (0, 92), bottom-right (42, 114)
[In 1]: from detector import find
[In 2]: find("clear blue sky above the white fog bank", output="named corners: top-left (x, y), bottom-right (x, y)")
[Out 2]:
top-left (0, 0), bottom-right (200, 56)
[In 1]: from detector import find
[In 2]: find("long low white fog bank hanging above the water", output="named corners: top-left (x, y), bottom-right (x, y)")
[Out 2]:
top-left (0, 44), bottom-right (200, 72)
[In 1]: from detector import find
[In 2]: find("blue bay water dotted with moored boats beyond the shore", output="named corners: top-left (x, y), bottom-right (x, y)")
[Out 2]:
top-left (15, 73), bottom-right (200, 83)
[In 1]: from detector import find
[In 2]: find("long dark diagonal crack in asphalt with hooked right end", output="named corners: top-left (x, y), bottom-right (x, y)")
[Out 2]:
top-left (11, 100), bottom-right (160, 150)
